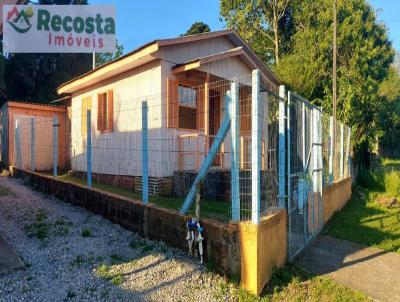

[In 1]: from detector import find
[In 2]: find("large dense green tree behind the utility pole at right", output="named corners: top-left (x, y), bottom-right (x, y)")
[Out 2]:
top-left (276, 0), bottom-right (394, 165)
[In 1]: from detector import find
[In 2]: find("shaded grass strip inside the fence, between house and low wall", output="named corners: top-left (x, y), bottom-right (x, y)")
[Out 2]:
top-left (53, 174), bottom-right (231, 222)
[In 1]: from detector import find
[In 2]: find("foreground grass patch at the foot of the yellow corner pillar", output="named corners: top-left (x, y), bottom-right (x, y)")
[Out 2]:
top-left (218, 265), bottom-right (372, 302)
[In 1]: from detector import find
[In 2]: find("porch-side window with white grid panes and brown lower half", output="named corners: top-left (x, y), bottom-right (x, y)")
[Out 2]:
top-left (178, 84), bottom-right (197, 129)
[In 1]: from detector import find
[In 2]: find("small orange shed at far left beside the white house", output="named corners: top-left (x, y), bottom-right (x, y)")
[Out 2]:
top-left (0, 101), bottom-right (70, 171)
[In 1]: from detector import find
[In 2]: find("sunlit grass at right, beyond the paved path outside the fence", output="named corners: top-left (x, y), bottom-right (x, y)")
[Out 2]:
top-left (327, 159), bottom-right (400, 254)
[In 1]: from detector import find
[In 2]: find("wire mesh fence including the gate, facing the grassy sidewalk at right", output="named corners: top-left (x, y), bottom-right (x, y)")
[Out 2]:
top-left (287, 92), bottom-right (351, 259)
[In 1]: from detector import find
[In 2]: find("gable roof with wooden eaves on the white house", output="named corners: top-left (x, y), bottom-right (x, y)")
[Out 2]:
top-left (57, 29), bottom-right (281, 94)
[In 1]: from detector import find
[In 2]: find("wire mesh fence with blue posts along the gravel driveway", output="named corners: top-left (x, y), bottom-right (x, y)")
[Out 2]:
top-left (11, 72), bottom-right (278, 222)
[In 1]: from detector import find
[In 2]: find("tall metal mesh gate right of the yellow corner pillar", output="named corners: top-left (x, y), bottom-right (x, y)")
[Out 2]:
top-left (287, 92), bottom-right (323, 260)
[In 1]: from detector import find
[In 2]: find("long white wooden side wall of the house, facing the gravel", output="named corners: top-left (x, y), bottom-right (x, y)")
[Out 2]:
top-left (71, 61), bottom-right (170, 177)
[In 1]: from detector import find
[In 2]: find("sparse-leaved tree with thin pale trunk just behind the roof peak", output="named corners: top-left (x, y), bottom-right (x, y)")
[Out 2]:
top-left (220, 0), bottom-right (291, 65)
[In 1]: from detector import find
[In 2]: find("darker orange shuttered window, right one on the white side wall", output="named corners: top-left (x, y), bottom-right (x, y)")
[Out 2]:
top-left (97, 90), bottom-right (114, 132)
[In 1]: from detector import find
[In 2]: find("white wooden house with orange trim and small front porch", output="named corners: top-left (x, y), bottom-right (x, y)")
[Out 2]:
top-left (58, 29), bottom-right (280, 193)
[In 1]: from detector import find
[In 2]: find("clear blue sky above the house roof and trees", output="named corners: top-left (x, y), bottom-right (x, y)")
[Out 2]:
top-left (90, 0), bottom-right (400, 52)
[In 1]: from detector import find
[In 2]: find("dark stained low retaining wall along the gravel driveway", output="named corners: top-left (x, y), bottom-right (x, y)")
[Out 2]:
top-left (11, 167), bottom-right (240, 278)
